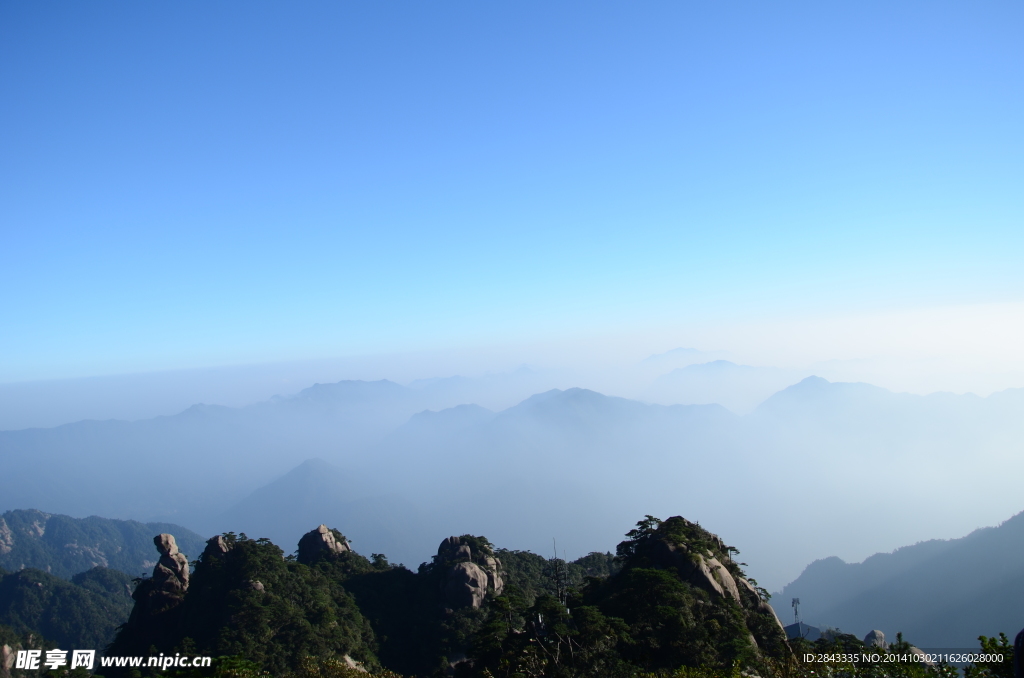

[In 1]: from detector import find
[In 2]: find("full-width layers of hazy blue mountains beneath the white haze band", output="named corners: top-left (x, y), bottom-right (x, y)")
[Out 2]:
top-left (0, 376), bottom-right (1024, 588)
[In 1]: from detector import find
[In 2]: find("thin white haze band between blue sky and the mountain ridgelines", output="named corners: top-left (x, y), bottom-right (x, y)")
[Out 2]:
top-left (0, 302), bottom-right (1024, 430)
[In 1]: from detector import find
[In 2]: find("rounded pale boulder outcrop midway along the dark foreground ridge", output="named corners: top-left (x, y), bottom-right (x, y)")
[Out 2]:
top-left (434, 537), bottom-right (505, 609)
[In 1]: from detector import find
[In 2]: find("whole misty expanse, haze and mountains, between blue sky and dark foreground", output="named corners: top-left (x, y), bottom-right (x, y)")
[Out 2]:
top-left (0, 304), bottom-right (1024, 589)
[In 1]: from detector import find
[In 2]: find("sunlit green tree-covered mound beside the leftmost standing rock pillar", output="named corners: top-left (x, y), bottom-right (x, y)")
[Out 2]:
top-left (109, 534), bottom-right (377, 675)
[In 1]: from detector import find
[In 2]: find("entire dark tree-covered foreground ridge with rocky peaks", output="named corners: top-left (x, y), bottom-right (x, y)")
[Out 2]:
top-left (94, 516), bottom-right (1010, 678)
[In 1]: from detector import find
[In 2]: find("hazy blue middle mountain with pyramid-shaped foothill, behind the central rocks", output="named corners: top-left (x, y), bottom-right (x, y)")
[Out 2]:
top-left (216, 389), bottom-right (735, 563)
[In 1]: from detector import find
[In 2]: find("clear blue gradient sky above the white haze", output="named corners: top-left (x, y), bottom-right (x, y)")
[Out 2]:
top-left (0, 0), bottom-right (1024, 381)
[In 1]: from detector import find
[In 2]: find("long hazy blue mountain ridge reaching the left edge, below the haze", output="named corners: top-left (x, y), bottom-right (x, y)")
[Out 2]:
top-left (0, 380), bottom-right (429, 525)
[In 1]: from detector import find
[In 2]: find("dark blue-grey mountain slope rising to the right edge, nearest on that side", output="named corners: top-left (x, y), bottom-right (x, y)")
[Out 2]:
top-left (774, 513), bottom-right (1024, 647)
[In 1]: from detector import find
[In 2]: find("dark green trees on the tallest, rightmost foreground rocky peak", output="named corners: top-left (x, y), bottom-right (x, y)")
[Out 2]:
top-left (463, 516), bottom-right (788, 676)
